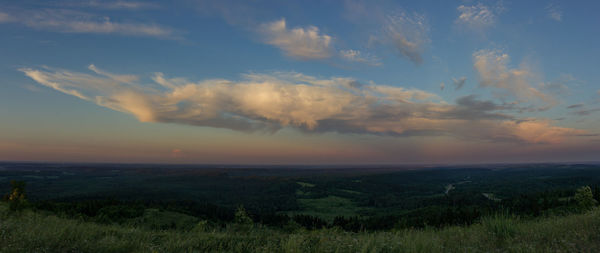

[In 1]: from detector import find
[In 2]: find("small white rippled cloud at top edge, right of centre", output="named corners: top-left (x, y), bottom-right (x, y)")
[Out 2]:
top-left (454, 3), bottom-right (503, 32)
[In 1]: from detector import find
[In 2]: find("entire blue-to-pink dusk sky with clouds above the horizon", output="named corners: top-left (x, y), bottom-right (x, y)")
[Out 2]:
top-left (0, 0), bottom-right (600, 164)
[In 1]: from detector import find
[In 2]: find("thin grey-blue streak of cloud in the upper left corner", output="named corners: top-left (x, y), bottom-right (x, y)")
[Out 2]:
top-left (0, 9), bottom-right (181, 39)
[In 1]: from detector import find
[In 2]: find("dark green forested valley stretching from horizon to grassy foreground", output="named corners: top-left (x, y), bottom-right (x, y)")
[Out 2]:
top-left (0, 163), bottom-right (600, 252)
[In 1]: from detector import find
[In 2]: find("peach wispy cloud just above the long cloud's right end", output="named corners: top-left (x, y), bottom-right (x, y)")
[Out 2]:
top-left (473, 50), bottom-right (556, 106)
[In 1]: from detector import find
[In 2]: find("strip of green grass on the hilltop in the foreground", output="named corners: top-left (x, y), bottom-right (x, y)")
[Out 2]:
top-left (0, 206), bottom-right (600, 252)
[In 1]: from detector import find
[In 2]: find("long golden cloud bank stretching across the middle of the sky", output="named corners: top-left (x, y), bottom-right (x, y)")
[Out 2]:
top-left (21, 65), bottom-right (585, 143)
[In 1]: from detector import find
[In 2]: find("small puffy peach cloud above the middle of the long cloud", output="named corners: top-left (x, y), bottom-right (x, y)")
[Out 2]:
top-left (259, 19), bottom-right (332, 60)
